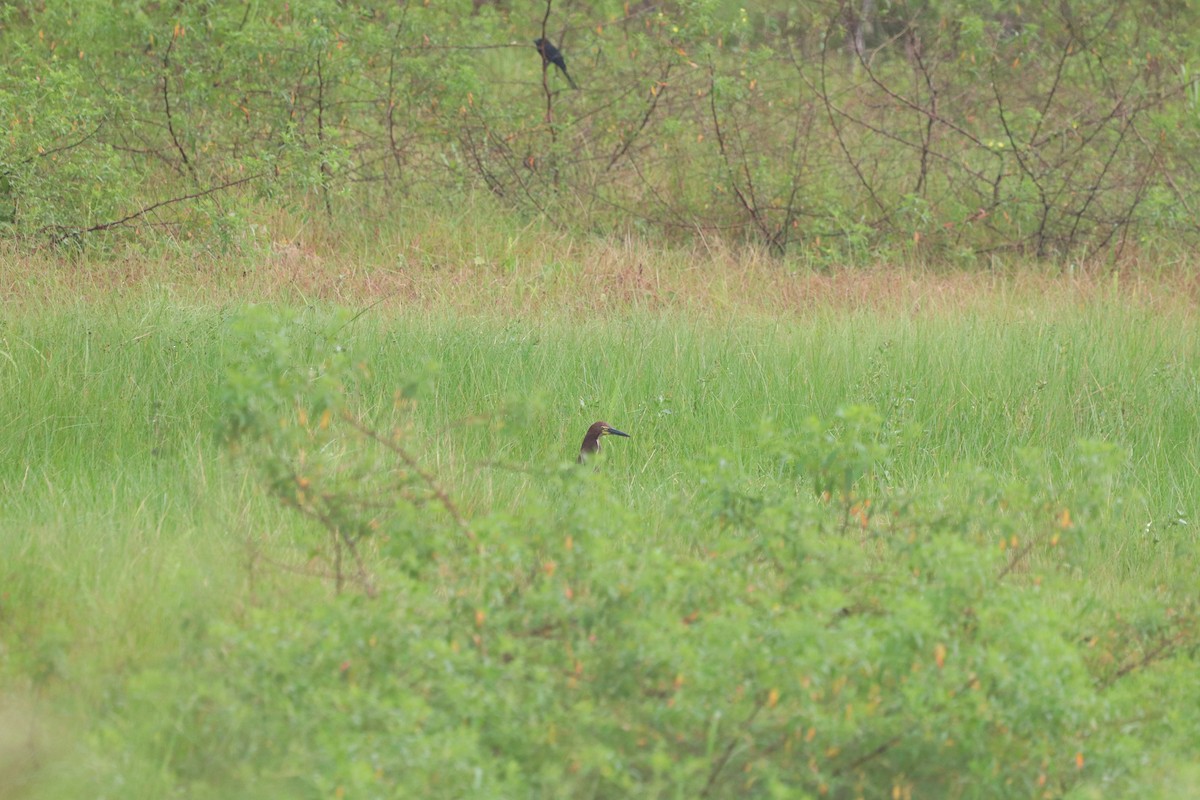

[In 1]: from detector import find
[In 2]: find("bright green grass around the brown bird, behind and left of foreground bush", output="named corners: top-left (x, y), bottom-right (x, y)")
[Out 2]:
top-left (0, 276), bottom-right (1200, 798)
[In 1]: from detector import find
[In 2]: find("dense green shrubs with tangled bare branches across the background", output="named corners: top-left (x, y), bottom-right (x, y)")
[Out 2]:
top-left (7, 0), bottom-right (1200, 260)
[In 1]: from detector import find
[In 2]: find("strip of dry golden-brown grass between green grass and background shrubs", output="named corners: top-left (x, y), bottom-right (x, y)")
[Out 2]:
top-left (7, 212), bottom-right (1200, 317)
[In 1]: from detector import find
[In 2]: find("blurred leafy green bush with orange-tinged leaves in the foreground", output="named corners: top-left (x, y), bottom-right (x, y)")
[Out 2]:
top-left (97, 312), bottom-right (1200, 798)
